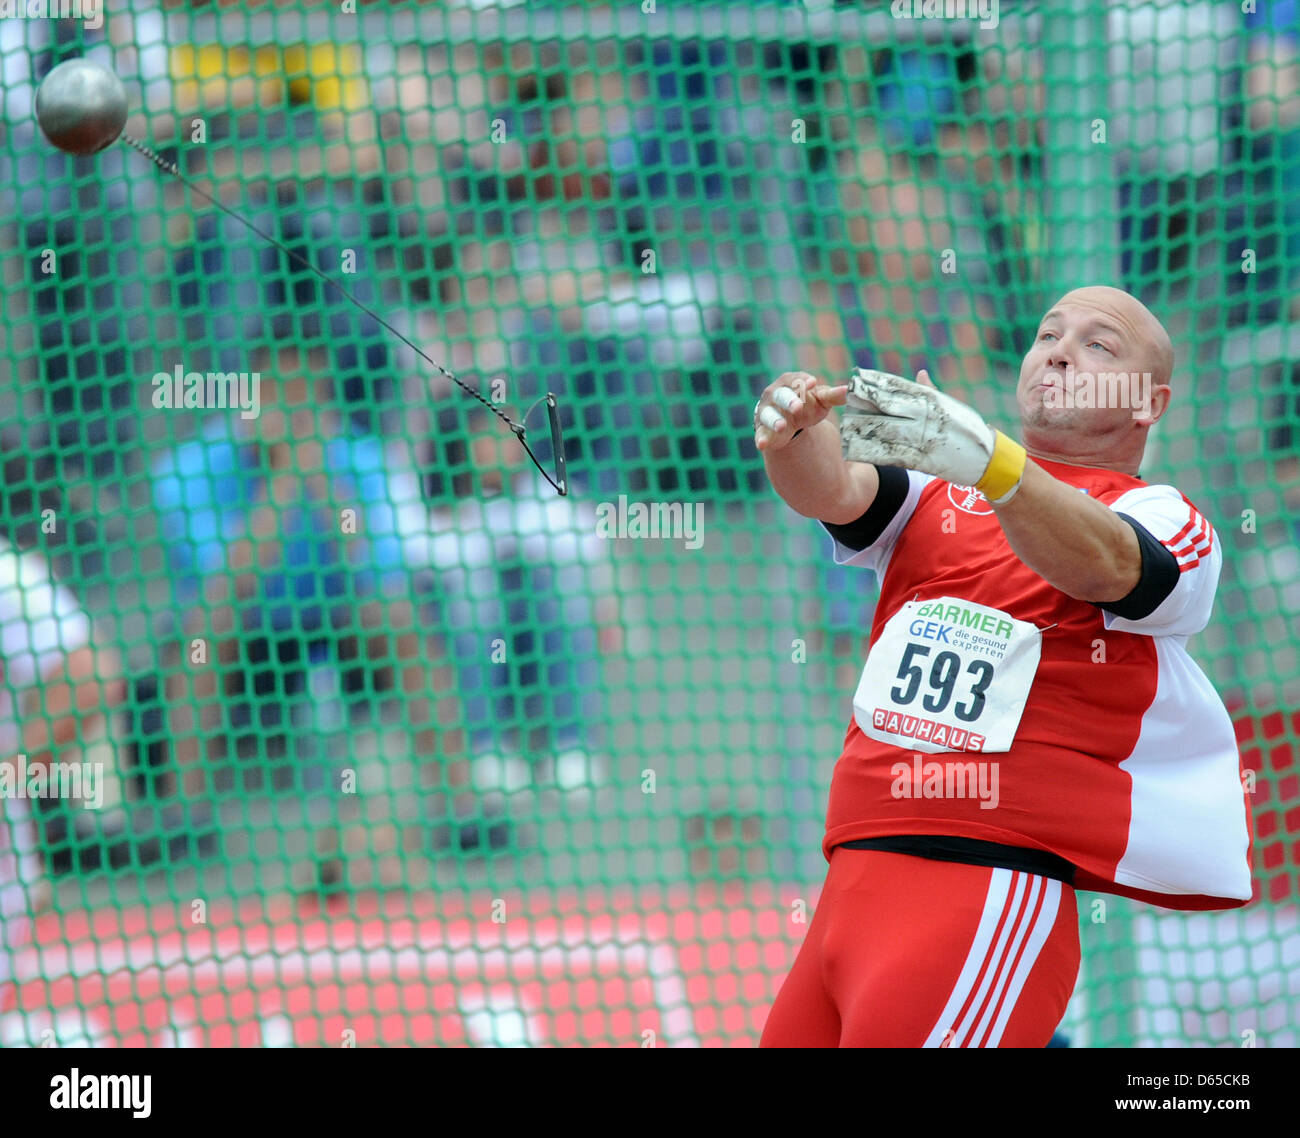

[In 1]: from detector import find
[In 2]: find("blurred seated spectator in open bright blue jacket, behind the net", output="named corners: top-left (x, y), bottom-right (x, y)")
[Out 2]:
top-left (155, 349), bottom-right (465, 884)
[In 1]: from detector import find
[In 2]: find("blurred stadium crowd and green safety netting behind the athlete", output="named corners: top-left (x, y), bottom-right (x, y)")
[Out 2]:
top-left (0, 0), bottom-right (1300, 1046)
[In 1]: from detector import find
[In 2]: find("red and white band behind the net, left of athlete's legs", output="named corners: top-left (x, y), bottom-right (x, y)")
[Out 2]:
top-left (18, 886), bottom-right (814, 1047)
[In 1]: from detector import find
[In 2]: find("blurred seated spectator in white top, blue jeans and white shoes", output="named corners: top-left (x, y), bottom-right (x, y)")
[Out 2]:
top-left (432, 410), bottom-right (621, 789)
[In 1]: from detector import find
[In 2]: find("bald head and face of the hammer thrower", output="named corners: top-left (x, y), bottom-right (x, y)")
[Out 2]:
top-left (1015, 289), bottom-right (1167, 442)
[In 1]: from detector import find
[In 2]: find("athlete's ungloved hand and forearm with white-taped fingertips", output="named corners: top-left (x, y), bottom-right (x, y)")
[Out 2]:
top-left (754, 372), bottom-right (880, 525)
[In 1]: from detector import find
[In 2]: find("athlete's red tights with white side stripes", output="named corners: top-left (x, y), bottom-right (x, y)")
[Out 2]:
top-left (759, 849), bottom-right (1079, 1047)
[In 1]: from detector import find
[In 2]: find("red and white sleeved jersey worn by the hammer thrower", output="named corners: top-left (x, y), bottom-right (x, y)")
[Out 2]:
top-left (823, 459), bottom-right (1251, 909)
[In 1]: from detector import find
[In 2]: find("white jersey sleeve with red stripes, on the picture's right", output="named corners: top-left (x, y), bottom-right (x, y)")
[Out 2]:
top-left (1101, 486), bottom-right (1223, 636)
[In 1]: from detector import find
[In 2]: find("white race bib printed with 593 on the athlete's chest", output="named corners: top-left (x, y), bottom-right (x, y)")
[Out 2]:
top-left (853, 597), bottom-right (1043, 753)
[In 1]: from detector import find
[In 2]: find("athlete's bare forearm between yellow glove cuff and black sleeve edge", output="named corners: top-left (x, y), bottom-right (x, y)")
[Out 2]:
top-left (993, 459), bottom-right (1143, 603)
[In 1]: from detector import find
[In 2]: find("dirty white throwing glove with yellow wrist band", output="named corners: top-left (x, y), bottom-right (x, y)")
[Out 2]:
top-left (840, 368), bottom-right (1026, 506)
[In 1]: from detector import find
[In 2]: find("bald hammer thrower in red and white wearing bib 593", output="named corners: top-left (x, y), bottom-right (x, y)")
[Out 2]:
top-left (755, 286), bottom-right (1251, 1047)
